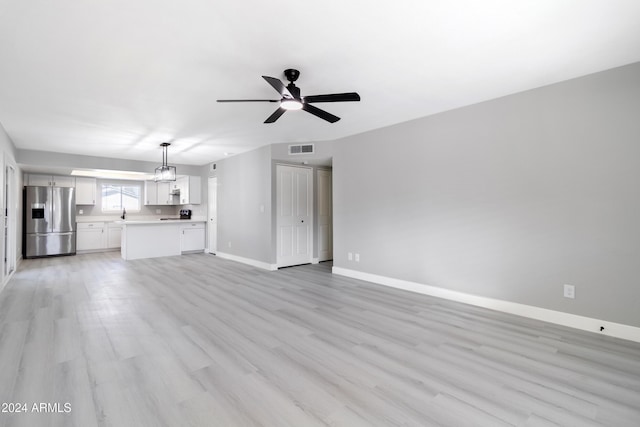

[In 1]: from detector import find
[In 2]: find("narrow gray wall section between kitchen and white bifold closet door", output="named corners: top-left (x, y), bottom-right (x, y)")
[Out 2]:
top-left (218, 146), bottom-right (275, 263)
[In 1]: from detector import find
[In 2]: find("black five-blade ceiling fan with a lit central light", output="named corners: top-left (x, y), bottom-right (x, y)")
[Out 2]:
top-left (218, 68), bottom-right (360, 123)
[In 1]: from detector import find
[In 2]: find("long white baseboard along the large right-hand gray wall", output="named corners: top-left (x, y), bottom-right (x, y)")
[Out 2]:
top-left (332, 267), bottom-right (640, 342)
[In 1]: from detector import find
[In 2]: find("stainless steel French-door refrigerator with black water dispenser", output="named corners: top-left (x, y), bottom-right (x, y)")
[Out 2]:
top-left (23, 187), bottom-right (76, 258)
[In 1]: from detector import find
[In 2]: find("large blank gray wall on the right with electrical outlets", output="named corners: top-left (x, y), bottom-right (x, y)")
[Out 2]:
top-left (333, 64), bottom-right (640, 326)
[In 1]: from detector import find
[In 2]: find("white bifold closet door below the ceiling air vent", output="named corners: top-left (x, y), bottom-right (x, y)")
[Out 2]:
top-left (276, 165), bottom-right (313, 267)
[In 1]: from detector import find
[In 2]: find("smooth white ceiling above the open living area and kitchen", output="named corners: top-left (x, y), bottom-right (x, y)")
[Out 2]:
top-left (0, 0), bottom-right (640, 165)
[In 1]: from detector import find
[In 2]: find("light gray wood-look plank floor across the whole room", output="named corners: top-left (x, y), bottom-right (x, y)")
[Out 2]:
top-left (0, 252), bottom-right (640, 427)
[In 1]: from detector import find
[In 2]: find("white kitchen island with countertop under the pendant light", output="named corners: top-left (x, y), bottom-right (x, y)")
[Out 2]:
top-left (118, 219), bottom-right (205, 260)
